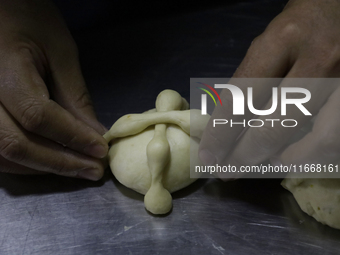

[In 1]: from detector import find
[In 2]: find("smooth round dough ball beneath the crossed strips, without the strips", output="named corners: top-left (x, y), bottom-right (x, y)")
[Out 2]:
top-left (109, 124), bottom-right (199, 195)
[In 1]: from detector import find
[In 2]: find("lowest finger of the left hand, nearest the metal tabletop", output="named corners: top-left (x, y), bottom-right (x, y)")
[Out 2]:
top-left (0, 102), bottom-right (104, 180)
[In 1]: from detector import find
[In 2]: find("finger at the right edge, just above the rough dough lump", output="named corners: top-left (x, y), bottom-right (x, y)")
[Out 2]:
top-left (279, 88), bottom-right (340, 165)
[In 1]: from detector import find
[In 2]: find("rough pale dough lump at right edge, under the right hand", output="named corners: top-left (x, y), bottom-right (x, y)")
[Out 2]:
top-left (282, 178), bottom-right (340, 229)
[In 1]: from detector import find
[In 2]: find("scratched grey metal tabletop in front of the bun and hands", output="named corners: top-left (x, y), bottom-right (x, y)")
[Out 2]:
top-left (0, 173), bottom-right (340, 254)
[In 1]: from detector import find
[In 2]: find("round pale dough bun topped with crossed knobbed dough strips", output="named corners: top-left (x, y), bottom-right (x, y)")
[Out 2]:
top-left (104, 90), bottom-right (210, 214)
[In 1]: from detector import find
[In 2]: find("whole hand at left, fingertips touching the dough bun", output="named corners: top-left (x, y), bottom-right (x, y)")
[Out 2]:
top-left (0, 0), bottom-right (108, 180)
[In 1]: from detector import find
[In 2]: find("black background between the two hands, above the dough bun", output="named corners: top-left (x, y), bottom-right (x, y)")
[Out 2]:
top-left (55, 0), bottom-right (287, 127)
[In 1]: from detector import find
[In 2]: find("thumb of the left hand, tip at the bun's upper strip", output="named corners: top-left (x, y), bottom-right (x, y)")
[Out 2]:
top-left (50, 49), bottom-right (107, 135)
